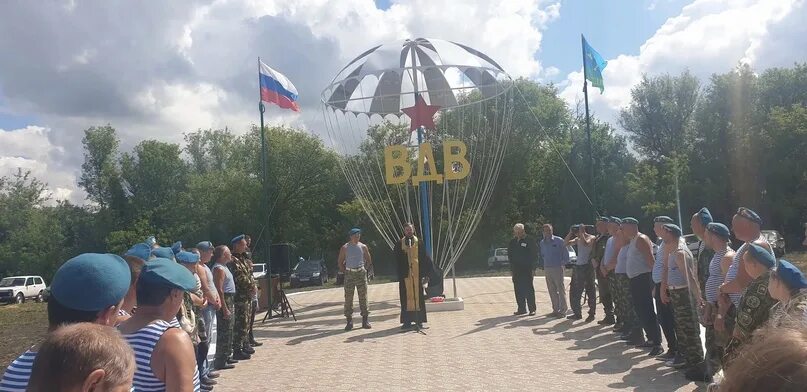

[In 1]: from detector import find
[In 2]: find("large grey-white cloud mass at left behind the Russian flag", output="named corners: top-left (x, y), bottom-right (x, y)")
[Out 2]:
top-left (0, 0), bottom-right (560, 201)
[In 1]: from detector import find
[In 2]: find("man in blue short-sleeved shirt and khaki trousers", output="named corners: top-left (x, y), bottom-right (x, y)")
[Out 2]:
top-left (539, 223), bottom-right (569, 318)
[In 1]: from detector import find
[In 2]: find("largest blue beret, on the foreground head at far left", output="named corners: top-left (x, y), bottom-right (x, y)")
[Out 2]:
top-left (50, 253), bottom-right (132, 312)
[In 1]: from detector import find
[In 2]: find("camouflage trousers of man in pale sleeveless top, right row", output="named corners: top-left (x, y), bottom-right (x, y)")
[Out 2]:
top-left (670, 288), bottom-right (703, 367)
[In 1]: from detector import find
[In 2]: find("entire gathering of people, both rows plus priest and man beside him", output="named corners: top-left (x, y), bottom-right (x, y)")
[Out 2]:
top-left (0, 208), bottom-right (807, 392)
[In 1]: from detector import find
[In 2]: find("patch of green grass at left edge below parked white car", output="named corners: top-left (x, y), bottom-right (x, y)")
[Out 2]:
top-left (0, 301), bottom-right (48, 372)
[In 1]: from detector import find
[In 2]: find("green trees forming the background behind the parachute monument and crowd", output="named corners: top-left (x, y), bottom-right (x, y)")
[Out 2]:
top-left (0, 64), bottom-right (807, 279)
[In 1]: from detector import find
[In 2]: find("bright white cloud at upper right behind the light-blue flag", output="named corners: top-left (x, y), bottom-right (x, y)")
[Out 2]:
top-left (562, 0), bottom-right (807, 122)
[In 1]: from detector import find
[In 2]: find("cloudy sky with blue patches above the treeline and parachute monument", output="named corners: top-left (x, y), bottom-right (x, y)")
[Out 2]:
top-left (0, 0), bottom-right (807, 204)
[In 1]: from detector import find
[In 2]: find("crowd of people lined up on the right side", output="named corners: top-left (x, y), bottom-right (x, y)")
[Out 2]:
top-left (508, 208), bottom-right (807, 391)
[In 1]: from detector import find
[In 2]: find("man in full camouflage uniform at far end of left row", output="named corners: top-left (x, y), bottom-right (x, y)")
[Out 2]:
top-left (230, 234), bottom-right (256, 359)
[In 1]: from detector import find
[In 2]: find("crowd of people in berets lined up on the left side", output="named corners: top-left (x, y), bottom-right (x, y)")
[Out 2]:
top-left (0, 235), bottom-right (261, 392)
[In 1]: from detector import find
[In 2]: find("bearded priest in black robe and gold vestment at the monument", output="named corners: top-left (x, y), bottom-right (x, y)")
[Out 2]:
top-left (393, 223), bottom-right (433, 330)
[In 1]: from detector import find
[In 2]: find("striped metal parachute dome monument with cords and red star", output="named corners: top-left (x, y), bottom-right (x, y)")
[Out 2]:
top-left (322, 38), bottom-right (514, 275)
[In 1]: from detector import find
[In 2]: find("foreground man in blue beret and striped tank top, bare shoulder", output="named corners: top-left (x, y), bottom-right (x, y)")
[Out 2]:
top-left (119, 258), bottom-right (200, 391)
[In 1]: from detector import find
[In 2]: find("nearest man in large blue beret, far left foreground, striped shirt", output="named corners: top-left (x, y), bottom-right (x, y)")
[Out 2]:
top-left (0, 253), bottom-right (131, 392)
